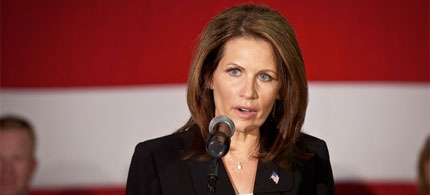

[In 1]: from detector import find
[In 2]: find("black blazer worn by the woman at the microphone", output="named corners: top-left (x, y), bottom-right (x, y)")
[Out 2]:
top-left (126, 125), bottom-right (334, 195)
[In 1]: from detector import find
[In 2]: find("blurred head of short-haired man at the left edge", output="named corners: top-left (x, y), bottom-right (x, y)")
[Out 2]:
top-left (0, 116), bottom-right (36, 195)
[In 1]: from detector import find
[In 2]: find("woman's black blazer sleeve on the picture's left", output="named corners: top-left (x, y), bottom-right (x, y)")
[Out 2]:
top-left (126, 142), bottom-right (161, 195)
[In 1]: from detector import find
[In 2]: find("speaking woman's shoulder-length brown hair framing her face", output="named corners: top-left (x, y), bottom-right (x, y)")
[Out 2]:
top-left (179, 4), bottom-right (308, 166)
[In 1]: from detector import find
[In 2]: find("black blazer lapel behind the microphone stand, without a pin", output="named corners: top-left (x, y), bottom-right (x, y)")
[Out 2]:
top-left (187, 159), bottom-right (235, 195)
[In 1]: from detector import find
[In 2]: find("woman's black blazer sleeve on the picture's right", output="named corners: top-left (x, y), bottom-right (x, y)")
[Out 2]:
top-left (316, 140), bottom-right (334, 195)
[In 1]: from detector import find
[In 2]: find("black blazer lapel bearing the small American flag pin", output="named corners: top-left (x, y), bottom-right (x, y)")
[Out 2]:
top-left (254, 161), bottom-right (294, 193)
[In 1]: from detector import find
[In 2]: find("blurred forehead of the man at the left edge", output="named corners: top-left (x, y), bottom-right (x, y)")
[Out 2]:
top-left (0, 128), bottom-right (33, 153)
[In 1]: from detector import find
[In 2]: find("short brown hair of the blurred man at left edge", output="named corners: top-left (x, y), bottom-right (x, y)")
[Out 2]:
top-left (0, 115), bottom-right (36, 157)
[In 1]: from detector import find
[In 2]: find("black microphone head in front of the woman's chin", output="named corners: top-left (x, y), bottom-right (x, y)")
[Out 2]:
top-left (206, 115), bottom-right (235, 158)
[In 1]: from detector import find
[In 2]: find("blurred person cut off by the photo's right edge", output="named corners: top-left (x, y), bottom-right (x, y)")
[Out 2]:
top-left (418, 136), bottom-right (430, 194)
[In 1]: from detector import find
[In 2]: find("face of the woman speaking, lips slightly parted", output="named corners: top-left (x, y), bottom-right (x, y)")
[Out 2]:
top-left (210, 37), bottom-right (279, 132)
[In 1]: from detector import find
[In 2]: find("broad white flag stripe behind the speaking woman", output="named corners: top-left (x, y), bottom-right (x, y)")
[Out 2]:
top-left (0, 82), bottom-right (430, 187)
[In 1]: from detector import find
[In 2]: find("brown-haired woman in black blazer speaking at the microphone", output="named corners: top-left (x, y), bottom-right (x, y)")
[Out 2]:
top-left (127, 5), bottom-right (333, 194)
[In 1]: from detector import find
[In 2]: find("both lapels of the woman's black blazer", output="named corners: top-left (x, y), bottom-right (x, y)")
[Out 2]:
top-left (187, 159), bottom-right (294, 195)
